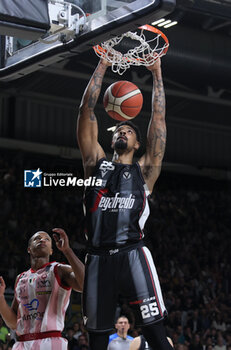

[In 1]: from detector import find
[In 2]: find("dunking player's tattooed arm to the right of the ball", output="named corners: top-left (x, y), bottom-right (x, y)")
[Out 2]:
top-left (139, 59), bottom-right (166, 192)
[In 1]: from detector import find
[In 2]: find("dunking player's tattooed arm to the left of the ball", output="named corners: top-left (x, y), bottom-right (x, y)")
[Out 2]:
top-left (77, 60), bottom-right (108, 176)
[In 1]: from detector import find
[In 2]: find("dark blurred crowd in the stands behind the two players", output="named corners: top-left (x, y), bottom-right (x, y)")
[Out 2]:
top-left (0, 150), bottom-right (231, 350)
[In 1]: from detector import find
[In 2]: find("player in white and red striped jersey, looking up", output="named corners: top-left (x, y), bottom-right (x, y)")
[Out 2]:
top-left (0, 228), bottom-right (84, 350)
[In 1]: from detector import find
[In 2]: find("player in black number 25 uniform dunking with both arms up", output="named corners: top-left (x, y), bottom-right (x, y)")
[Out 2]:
top-left (77, 60), bottom-right (172, 350)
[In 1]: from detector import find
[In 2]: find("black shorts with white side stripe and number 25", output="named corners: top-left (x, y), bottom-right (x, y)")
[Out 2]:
top-left (83, 246), bottom-right (167, 332)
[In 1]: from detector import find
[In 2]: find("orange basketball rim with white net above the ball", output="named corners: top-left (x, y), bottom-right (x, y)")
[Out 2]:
top-left (94, 24), bottom-right (169, 75)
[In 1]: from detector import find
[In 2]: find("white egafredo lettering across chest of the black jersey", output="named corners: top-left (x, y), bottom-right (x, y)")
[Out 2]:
top-left (99, 192), bottom-right (135, 211)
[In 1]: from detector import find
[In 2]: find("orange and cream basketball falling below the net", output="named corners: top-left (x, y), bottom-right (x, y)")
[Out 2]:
top-left (103, 80), bottom-right (143, 121)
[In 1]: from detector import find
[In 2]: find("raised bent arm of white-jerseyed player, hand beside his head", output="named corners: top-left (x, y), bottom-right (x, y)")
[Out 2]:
top-left (52, 228), bottom-right (85, 292)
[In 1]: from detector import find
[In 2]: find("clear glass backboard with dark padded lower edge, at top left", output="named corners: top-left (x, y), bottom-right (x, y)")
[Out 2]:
top-left (0, 0), bottom-right (175, 81)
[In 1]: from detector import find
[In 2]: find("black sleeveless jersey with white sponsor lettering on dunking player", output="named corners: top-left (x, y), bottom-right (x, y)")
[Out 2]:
top-left (85, 158), bottom-right (149, 248)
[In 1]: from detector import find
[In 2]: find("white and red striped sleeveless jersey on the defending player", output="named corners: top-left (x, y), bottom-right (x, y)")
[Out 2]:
top-left (15, 262), bottom-right (71, 335)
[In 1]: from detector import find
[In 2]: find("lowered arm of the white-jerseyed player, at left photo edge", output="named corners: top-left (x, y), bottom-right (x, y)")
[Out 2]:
top-left (0, 276), bottom-right (18, 329)
